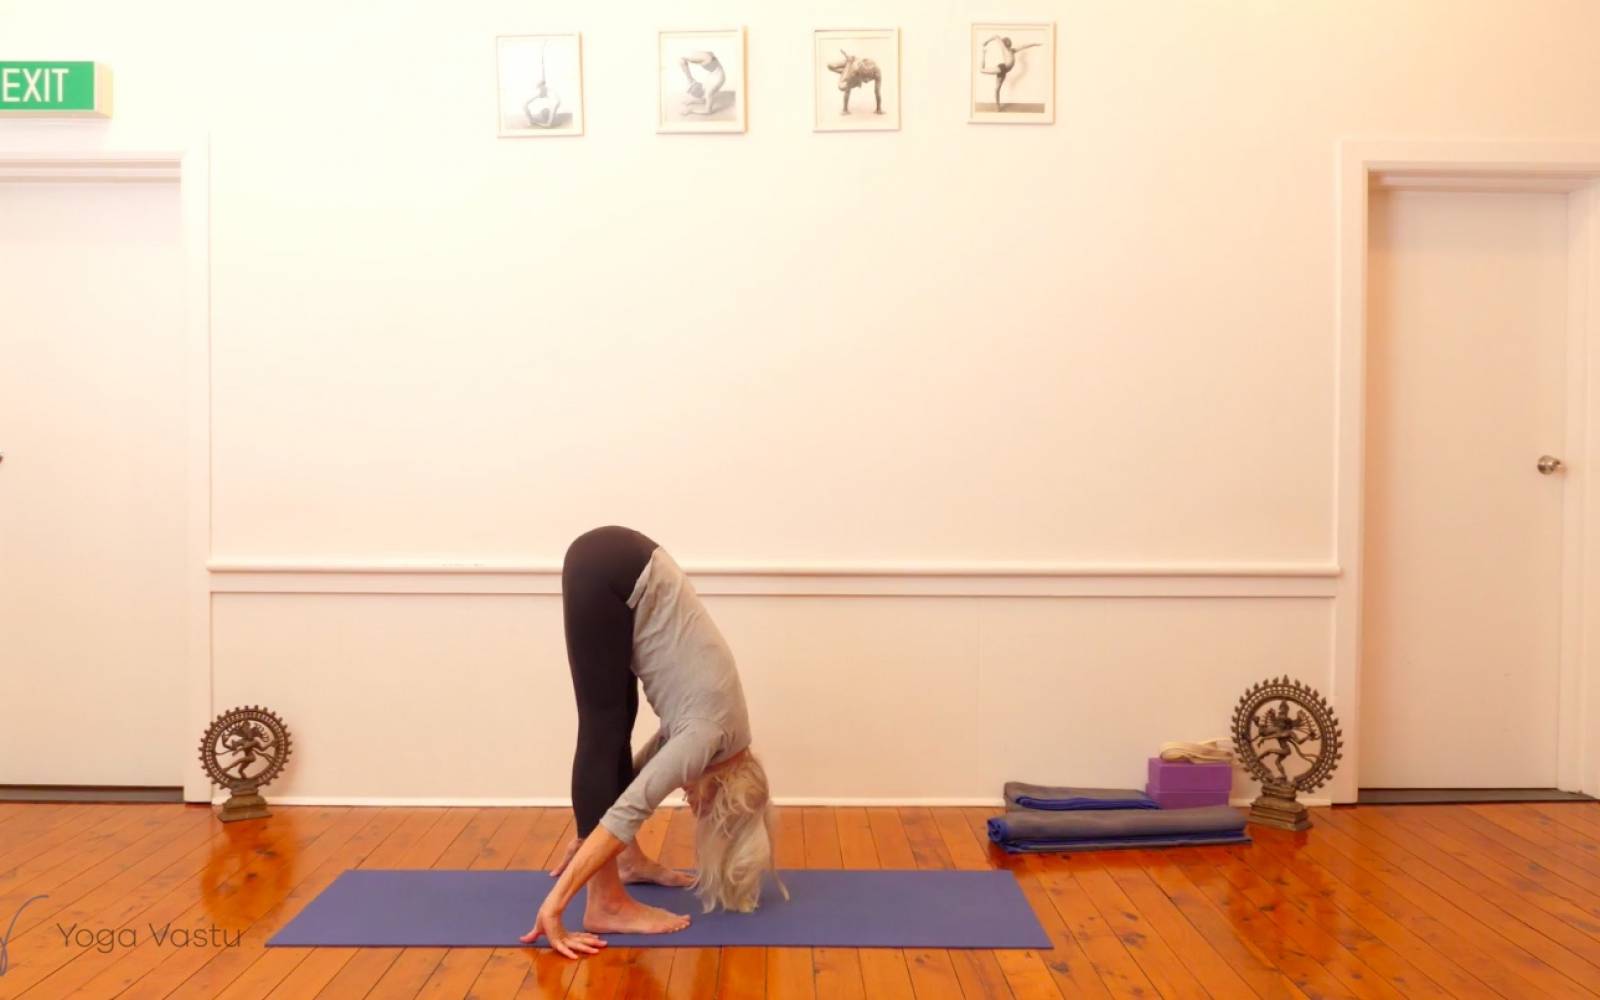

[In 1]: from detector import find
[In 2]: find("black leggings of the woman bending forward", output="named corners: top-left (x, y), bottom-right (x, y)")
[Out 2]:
top-left (562, 526), bottom-right (656, 837)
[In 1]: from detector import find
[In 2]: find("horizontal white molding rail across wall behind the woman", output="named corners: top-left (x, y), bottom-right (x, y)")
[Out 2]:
top-left (208, 558), bottom-right (1339, 597)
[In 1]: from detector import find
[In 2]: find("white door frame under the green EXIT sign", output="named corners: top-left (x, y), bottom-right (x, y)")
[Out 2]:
top-left (0, 140), bottom-right (211, 802)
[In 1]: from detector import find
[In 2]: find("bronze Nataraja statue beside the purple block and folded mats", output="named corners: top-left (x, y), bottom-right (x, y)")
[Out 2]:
top-left (1234, 677), bottom-right (1344, 830)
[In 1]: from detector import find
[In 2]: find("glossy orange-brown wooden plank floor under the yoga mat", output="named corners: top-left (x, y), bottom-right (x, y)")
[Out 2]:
top-left (0, 803), bottom-right (1600, 1000)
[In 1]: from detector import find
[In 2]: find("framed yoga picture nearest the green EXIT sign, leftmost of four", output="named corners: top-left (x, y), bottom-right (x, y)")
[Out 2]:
top-left (494, 34), bottom-right (584, 136)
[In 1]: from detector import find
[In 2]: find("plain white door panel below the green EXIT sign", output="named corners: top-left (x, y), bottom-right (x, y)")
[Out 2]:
top-left (0, 182), bottom-right (188, 786)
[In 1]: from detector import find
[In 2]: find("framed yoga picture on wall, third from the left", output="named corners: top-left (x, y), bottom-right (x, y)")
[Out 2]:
top-left (811, 27), bottom-right (899, 131)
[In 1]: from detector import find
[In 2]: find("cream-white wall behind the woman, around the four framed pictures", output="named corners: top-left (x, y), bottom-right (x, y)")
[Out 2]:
top-left (9, 0), bottom-right (1600, 797)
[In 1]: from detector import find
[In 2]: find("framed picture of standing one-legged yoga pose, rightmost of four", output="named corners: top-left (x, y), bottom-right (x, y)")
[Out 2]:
top-left (966, 21), bottom-right (1056, 125)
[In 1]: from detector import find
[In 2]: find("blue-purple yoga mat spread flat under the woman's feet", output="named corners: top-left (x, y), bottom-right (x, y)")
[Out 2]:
top-left (267, 869), bottom-right (1050, 949)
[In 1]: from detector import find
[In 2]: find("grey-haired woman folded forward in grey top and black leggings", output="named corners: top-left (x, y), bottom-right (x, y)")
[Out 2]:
top-left (522, 526), bottom-right (789, 958)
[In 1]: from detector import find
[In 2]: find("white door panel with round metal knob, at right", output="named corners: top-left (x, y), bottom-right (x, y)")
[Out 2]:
top-left (1360, 190), bottom-right (1568, 789)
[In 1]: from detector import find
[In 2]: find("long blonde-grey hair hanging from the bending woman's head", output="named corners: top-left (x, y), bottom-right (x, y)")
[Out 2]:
top-left (694, 750), bottom-right (789, 914)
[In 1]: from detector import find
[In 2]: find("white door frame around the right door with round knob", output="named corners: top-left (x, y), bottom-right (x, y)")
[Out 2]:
top-left (1331, 141), bottom-right (1600, 802)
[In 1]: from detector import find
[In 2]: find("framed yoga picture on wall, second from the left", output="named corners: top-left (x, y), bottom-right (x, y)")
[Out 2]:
top-left (656, 27), bottom-right (744, 131)
